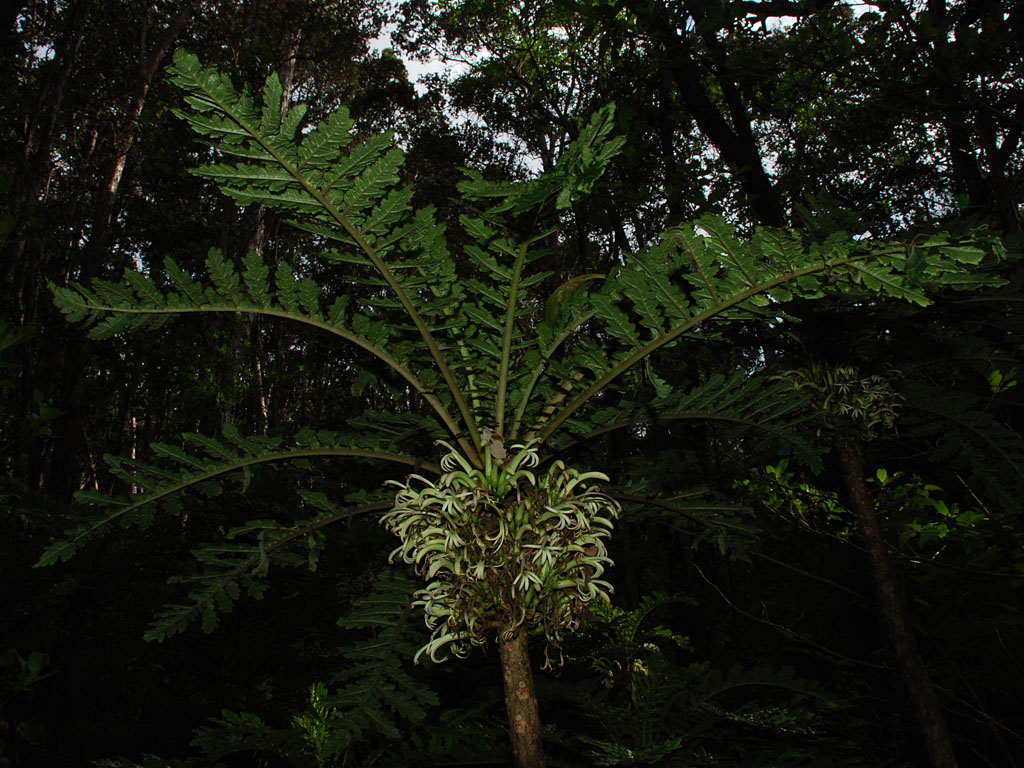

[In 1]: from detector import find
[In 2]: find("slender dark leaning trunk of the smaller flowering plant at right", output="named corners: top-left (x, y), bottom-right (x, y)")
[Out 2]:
top-left (836, 427), bottom-right (956, 768)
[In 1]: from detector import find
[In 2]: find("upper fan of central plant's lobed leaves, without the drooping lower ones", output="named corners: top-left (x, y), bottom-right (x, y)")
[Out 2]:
top-left (53, 51), bottom-right (999, 475)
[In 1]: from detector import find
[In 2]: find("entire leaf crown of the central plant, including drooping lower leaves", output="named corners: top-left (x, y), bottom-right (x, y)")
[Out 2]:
top-left (46, 41), bottom-right (999, 639)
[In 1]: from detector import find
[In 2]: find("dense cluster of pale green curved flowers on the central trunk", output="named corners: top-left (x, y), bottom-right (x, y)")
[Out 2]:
top-left (381, 435), bottom-right (620, 667)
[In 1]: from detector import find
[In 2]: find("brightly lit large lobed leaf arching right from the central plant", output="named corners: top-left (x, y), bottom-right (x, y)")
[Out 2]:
top-left (539, 216), bottom-right (999, 439)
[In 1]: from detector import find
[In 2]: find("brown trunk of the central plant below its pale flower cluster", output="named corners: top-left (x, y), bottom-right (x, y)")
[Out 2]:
top-left (498, 625), bottom-right (545, 768)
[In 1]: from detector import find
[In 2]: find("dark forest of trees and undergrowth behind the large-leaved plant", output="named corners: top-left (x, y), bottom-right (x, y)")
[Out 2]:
top-left (0, 0), bottom-right (1024, 768)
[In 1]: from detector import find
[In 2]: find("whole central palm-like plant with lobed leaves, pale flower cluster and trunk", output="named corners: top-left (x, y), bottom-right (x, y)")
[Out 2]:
top-left (40, 51), bottom-right (999, 767)
